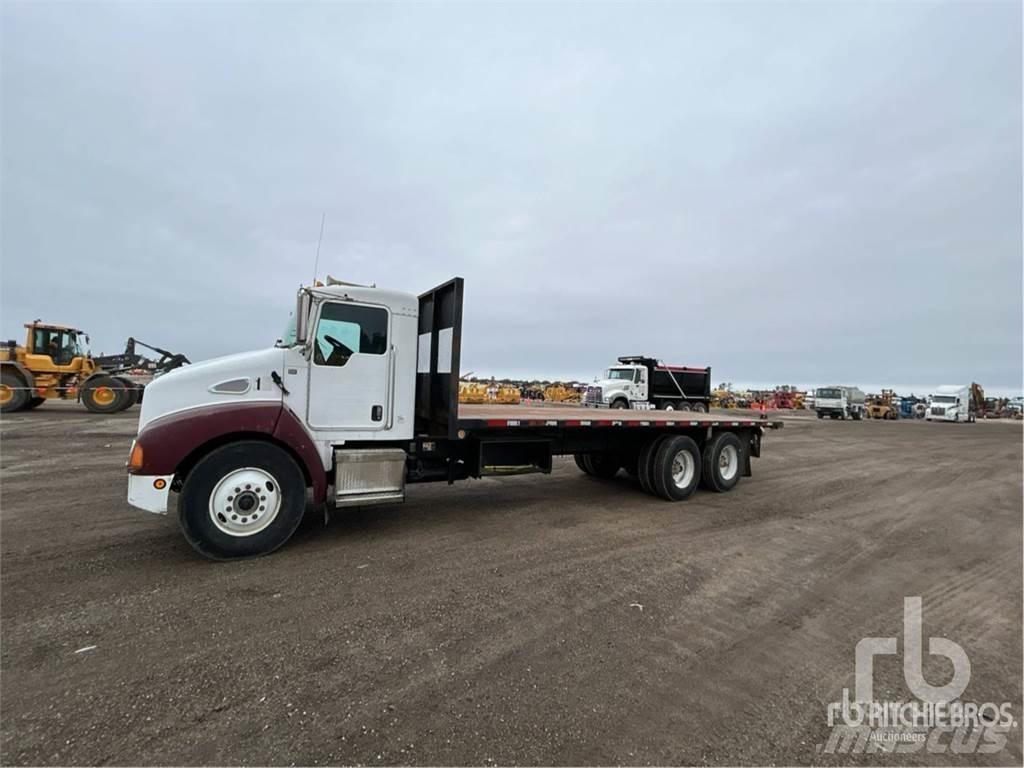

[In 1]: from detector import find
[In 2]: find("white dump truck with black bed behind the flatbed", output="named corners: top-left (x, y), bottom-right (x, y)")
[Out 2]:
top-left (583, 355), bottom-right (711, 413)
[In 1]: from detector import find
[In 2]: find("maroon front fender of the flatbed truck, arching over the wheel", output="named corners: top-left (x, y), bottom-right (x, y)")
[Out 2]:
top-left (135, 402), bottom-right (327, 502)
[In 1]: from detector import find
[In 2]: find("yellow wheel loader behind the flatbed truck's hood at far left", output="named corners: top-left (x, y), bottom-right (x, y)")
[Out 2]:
top-left (0, 319), bottom-right (141, 414)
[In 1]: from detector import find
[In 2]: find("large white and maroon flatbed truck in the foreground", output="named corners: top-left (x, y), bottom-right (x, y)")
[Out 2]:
top-left (127, 278), bottom-right (782, 559)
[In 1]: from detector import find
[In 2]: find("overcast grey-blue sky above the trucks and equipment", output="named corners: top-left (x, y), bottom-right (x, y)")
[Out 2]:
top-left (0, 2), bottom-right (1022, 391)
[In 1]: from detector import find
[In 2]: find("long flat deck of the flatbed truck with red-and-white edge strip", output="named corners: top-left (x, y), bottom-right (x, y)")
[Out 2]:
top-left (459, 403), bottom-right (782, 429)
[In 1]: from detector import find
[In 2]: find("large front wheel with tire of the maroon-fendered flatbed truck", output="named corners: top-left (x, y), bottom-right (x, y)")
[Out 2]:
top-left (178, 440), bottom-right (306, 560)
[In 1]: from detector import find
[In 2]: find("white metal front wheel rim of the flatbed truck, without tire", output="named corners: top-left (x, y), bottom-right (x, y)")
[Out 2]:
top-left (210, 467), bottom-right (281, 537)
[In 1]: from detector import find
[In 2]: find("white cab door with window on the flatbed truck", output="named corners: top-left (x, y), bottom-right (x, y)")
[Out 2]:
top-left (306, 301), bottom-right (394, 431)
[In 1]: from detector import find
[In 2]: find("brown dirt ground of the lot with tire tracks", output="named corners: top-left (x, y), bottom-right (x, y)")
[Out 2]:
top-left (0, 403), bottom-right (1022, 765)
